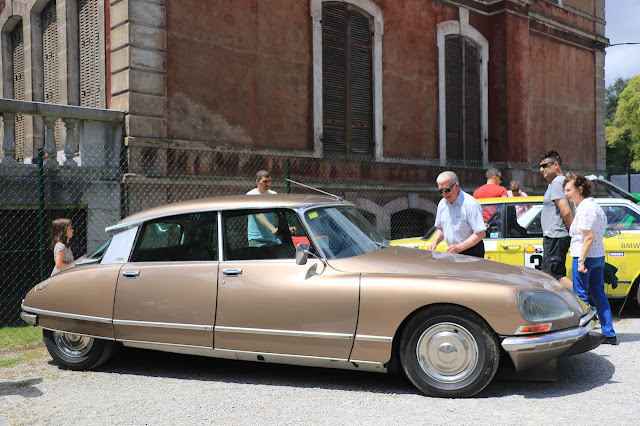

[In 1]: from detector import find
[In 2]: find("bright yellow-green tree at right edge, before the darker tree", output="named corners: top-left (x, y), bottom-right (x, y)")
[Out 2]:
top-left (606, 75), bottom-right (640, 170)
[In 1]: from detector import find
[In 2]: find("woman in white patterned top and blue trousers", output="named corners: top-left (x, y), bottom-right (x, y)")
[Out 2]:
top-left (564, 174), bottom-right (618, 345)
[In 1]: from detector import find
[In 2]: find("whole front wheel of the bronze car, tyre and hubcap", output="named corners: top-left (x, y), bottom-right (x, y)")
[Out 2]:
top-left (400, 306), bottom-right (500, 398)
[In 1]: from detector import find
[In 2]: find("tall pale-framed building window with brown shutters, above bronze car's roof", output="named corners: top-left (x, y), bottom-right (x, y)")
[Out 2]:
top-left (310, 0), bottom-right (383, 159)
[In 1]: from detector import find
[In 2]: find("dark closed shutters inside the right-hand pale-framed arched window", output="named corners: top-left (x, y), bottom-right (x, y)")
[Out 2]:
top-left (444, 35), bottom-right (482, 161)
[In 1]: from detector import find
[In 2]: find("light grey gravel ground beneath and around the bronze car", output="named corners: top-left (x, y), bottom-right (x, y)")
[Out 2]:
top-left (0, 306), bottom-right (640, 426)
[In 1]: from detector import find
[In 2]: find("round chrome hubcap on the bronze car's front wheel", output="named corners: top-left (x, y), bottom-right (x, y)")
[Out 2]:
top-left (416, 322), bottom-right (478, 383)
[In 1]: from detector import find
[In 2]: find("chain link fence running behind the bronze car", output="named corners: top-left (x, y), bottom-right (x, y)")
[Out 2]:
top-left (0, 147), bottom-right (608, 347)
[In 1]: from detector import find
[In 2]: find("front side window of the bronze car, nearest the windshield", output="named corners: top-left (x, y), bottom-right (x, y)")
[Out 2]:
top-left (223, 209), bottom-right (309, 260)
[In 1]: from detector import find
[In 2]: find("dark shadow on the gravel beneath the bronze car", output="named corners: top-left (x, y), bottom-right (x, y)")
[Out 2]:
top-left (84, 333), bottom-right (640, 399)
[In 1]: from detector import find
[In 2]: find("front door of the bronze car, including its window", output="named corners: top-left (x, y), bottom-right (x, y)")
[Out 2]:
top-left (214, 209), bottom-right (360, 359)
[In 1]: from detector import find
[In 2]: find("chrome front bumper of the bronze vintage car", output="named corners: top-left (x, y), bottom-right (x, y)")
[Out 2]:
top-left (502, 310), bottom-right (604, 371)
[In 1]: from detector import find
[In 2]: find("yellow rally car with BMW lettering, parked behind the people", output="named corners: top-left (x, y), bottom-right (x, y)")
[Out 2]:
top-left (391, 197), bottom-right (640, 303)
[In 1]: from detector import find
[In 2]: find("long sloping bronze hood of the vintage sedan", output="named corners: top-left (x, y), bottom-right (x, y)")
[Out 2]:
top-left (329, 246), bottom-right (565, 291)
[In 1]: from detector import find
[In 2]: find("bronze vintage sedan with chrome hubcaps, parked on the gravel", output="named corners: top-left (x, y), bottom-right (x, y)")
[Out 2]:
top-left (22, 195), bottom-right (604, 397)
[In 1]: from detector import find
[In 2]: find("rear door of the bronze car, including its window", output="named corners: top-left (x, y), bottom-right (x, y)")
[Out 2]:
top-left (113, 212), bottom-right (218, 348)
